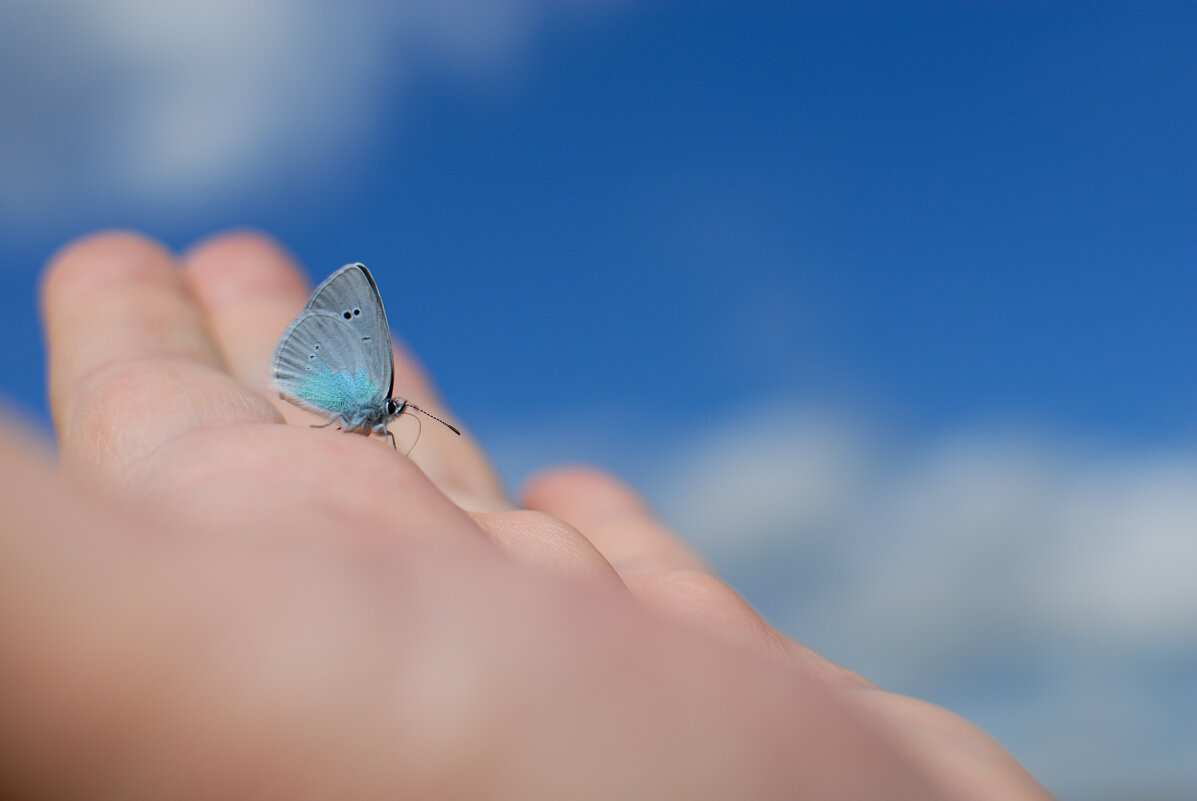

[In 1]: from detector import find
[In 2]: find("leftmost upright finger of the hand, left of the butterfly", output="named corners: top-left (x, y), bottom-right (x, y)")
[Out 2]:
top-left (42, 232), bottom-right (277, 481)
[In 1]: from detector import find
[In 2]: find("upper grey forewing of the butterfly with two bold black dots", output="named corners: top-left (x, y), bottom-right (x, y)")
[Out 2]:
top-left (305, 263), bottom-right (395, 398)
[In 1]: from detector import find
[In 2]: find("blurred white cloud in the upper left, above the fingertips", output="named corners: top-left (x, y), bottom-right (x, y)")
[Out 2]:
top-left (0, 0), bottom-right (632, 225)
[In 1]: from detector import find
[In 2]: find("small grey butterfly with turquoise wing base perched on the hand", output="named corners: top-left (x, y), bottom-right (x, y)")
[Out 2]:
top-left (274, 263), bottom-right (461, 448)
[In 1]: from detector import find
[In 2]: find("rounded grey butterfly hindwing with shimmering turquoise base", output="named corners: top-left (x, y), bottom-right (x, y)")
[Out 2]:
top-left (274, 310), bottom-right (390, 425)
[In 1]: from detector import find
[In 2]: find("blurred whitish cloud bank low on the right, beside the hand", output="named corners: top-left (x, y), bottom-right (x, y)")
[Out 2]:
top-left (498, 402), bottom-right (1197, 797)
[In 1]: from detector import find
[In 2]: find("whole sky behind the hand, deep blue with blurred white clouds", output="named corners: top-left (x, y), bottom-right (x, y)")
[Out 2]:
top-left (0, 0), bottom-right (1197, 797)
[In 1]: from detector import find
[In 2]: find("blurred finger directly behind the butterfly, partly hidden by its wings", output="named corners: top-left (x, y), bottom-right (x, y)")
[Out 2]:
top-left (184, 232), bottom-right (510, 510)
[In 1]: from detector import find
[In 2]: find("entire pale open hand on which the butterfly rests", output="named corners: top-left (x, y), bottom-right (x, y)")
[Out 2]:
top-left (0, 227), bottom-right (1049, 801)
